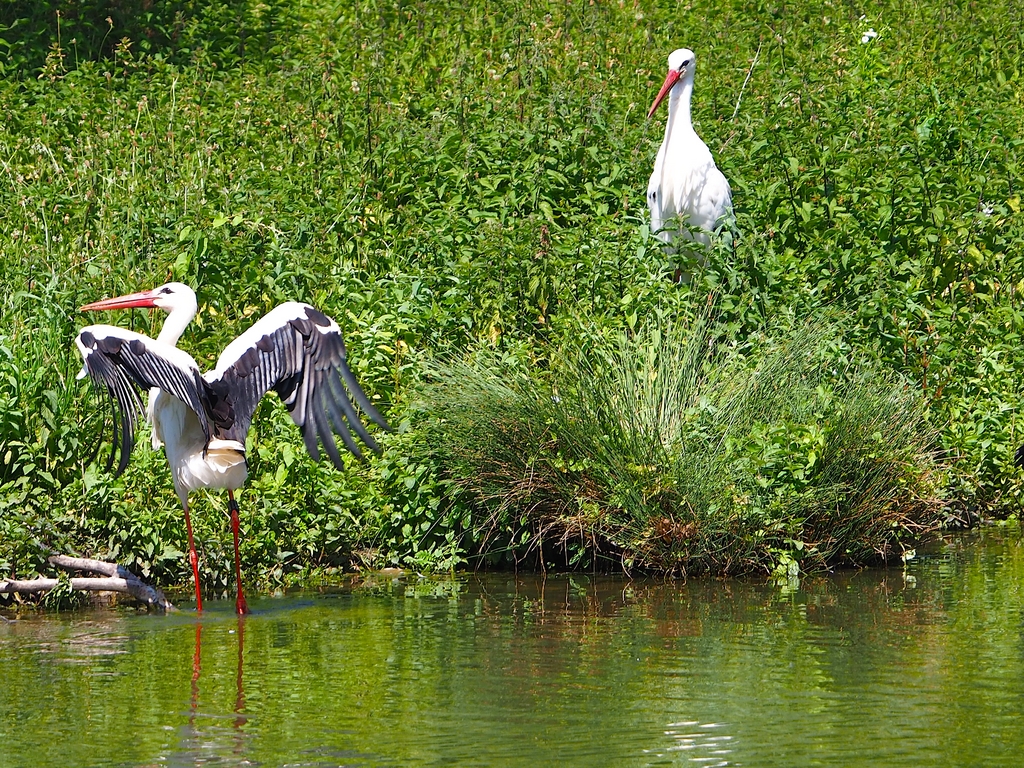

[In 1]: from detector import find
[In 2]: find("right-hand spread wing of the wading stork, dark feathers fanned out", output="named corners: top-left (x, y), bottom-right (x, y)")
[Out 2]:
top-left (206, 302), bottom-right (389, 469)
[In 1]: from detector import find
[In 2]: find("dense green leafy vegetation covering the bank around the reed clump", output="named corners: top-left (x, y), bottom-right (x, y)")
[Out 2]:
top-left (0, 0), bottom-right (1024, 584)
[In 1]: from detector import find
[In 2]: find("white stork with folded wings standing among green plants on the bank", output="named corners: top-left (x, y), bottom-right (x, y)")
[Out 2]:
top-left (647, 48), bottom-right (732, 270)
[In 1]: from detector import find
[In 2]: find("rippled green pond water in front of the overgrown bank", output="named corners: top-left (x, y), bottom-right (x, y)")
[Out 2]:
top-left (0, 528), bottom-right (1024, 767)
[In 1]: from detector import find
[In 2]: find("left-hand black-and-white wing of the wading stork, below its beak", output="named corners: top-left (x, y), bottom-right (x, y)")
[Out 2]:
top-left (75, 326), bottom-right (210, 474)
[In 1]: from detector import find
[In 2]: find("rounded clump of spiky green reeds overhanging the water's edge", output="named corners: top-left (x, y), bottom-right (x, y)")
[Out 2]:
top-left (424, 323), bottom-right (941, 574)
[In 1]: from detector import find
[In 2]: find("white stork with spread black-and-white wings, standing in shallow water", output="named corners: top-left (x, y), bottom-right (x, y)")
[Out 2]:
top-left (75, 283), bottom-right (388, 614)
